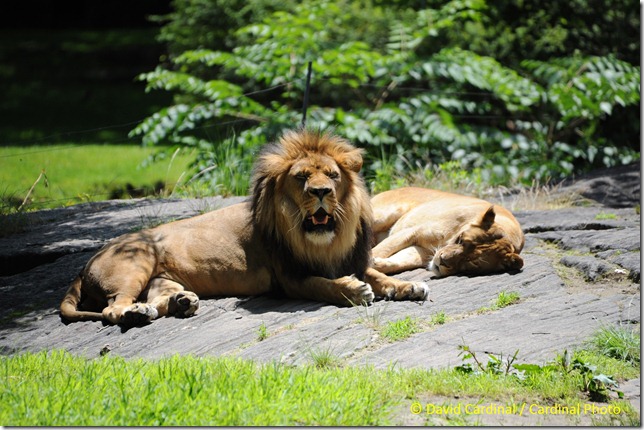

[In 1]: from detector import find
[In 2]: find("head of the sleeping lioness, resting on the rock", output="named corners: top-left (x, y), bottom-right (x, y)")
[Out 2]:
top-left (429, 206), bottom-right (523, 277)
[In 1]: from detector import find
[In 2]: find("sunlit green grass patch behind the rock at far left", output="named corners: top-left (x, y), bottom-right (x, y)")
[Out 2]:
top-left (0, 144), bottom-right (191, 213)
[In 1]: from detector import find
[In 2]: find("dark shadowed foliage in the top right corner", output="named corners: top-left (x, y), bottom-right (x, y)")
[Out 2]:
top-left (427, 0), bottom-right (640, 66)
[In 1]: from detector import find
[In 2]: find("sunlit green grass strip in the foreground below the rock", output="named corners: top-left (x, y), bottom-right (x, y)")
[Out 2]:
top-left (0, 351), bottom-right (639, 426)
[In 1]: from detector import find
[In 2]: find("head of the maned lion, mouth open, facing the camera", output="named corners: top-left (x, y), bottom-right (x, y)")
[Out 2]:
top-left (252, 130), bottom-right (372, 268)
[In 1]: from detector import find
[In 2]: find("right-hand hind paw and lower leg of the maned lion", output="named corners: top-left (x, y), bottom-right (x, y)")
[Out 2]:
top-left (147, 278), bottom-right (199, 317)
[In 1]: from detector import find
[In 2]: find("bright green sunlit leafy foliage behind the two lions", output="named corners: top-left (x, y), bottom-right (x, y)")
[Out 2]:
top-left (132, 0), bottom-right (640, 192)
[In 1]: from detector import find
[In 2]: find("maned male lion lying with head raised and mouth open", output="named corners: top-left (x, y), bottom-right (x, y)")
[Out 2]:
top-left (60, 129), bottom-right (428, 326)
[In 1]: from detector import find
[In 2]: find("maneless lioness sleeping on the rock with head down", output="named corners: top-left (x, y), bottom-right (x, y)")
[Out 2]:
top-left (371, 187), bottom-right (525, 277)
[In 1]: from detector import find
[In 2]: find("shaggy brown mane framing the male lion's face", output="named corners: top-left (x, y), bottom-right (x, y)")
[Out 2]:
top-left (251, 130), bottom-right (373, 278)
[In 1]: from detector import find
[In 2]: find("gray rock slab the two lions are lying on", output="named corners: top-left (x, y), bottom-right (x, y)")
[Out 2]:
top-left (0, 162), bottom-right (641, 420)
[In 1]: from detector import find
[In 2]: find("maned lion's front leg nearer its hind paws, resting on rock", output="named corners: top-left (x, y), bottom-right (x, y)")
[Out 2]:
top-left (281, 276), bottom-right (375, 306)
